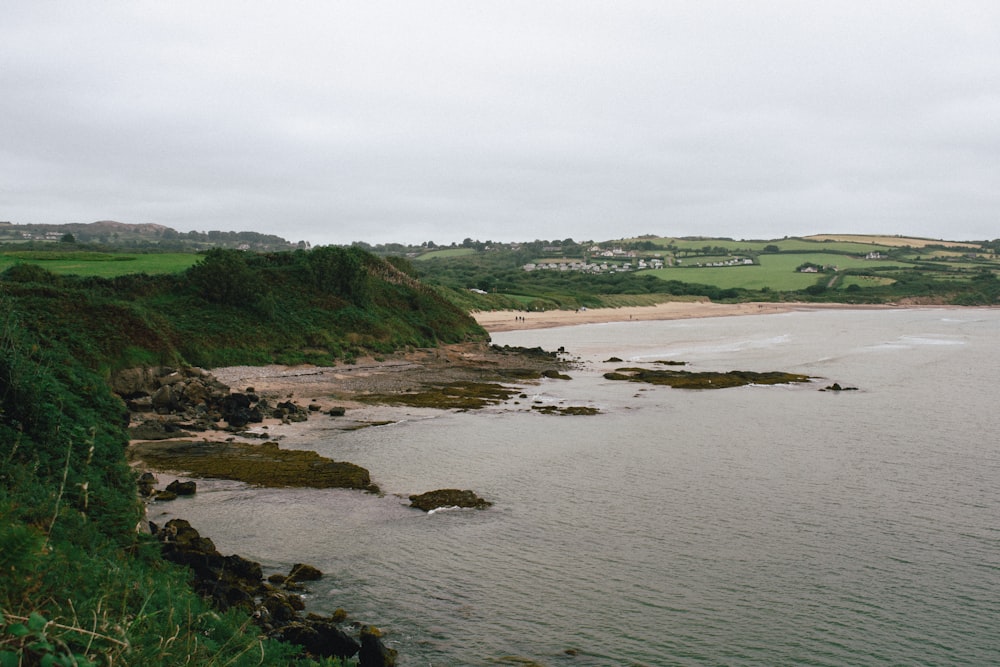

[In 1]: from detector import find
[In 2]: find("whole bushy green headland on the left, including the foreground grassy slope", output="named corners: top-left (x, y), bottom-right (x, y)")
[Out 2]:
top-left (0, 248), bottom-right (486, 665)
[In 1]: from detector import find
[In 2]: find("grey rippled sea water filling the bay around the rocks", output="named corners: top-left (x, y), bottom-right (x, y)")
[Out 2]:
top-left (153, 309), bottom-right (1000, 666)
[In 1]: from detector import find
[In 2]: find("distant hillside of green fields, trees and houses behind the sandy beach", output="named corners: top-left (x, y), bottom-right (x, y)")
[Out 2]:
top-left (410, 235), bottom-right (1000, 311)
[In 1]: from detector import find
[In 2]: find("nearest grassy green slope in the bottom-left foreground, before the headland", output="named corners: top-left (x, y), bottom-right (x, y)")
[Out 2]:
top-left (0, 314), bottom-right (346, 665)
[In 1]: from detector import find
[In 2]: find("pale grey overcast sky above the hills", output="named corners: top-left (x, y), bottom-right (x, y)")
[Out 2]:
top-left (0, 0), bottom-right (1000, 245)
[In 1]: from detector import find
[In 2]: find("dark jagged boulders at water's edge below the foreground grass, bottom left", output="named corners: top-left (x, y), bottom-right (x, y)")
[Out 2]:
top-left (151, 519), bottom-right (396, 667)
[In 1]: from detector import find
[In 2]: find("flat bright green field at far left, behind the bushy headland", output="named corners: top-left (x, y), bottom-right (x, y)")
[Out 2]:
top-left (0, 251), bottom-right (201, 278)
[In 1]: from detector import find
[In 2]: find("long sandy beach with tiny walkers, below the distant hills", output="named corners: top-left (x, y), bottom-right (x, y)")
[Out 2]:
top-left (471, 301), bottom-right (904, 333)
